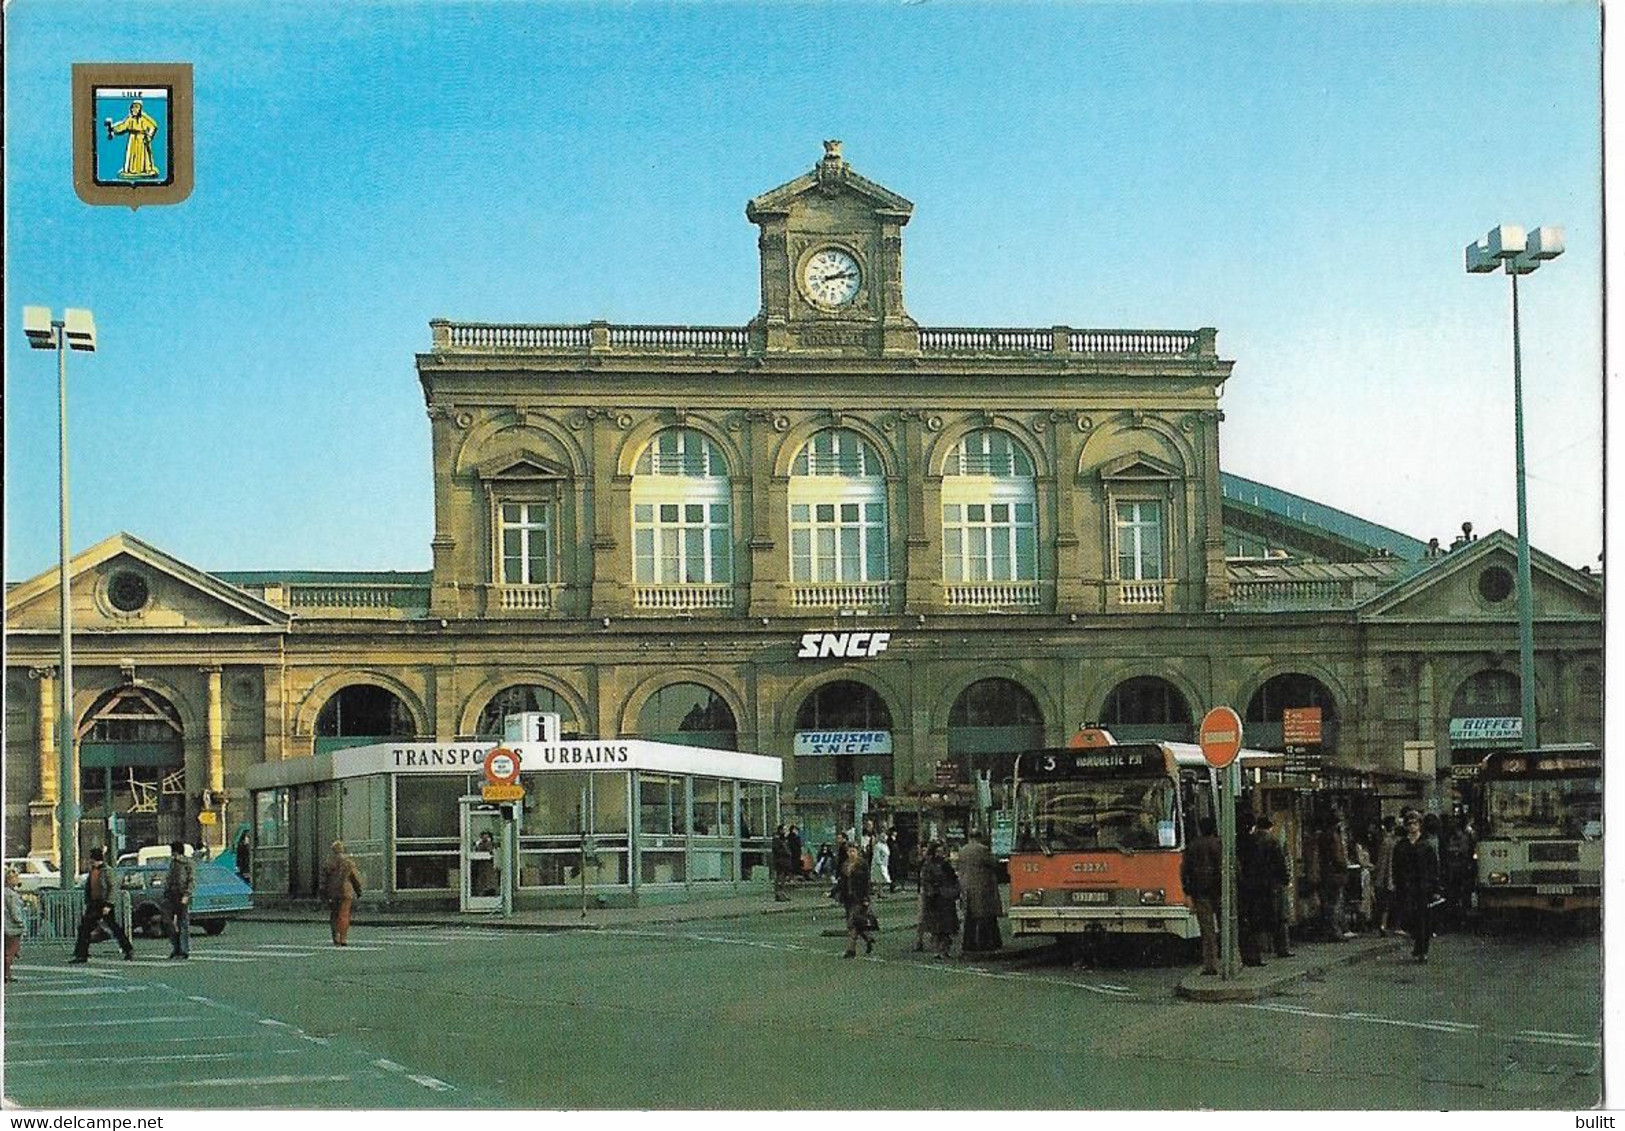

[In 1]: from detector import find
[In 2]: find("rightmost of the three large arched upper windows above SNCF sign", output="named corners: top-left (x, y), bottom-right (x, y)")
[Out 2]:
top-left (943, 429), bottom-right (1038, 583)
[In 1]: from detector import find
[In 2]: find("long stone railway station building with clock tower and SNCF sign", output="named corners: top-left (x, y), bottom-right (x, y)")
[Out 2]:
top-left (5, 143), bottom-right (1602, 889)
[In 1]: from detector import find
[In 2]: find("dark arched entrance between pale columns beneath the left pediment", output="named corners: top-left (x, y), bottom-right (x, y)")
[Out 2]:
top-left (80, 684), bottom-right (192, 856)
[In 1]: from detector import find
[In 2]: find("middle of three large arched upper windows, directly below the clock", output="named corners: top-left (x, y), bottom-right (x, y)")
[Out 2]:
top-left (790, 427), bottom-right (891, 585)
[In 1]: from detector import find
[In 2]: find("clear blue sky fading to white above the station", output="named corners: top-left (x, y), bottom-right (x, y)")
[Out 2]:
top-left (5, 0), bottom-right (1602, 580)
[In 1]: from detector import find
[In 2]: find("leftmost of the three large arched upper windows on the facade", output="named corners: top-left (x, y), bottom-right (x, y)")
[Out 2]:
top-left (632, 427), bottom-right (733, 600)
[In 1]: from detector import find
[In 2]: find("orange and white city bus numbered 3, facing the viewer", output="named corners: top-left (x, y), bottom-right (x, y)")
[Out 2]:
top-left (1009, 739), bottom-right (1281, 939)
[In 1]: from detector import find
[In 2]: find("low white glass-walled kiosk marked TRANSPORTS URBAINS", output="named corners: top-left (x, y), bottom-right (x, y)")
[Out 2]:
top-left (247, 739), bottom-right (783, 912)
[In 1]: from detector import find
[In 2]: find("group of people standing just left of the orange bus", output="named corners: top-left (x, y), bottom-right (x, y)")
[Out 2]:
top-left (772, 824), bottom-right (1004, 960)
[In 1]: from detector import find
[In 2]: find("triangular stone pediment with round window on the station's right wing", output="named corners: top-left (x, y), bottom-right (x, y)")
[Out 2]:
top-left (1359, 530), bottom-right (1602, 627)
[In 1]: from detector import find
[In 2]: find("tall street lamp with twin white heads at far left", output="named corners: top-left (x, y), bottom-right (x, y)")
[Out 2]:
top-left (23, 307), bottom-right (96, 886)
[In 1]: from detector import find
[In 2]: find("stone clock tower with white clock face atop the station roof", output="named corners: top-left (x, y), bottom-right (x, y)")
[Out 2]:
top-left (744, 141), bottom-right (920, 356)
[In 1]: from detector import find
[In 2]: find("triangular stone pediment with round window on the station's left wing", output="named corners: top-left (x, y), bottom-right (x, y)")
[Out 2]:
top-left (5, 533), bottom-right (289, 632)
